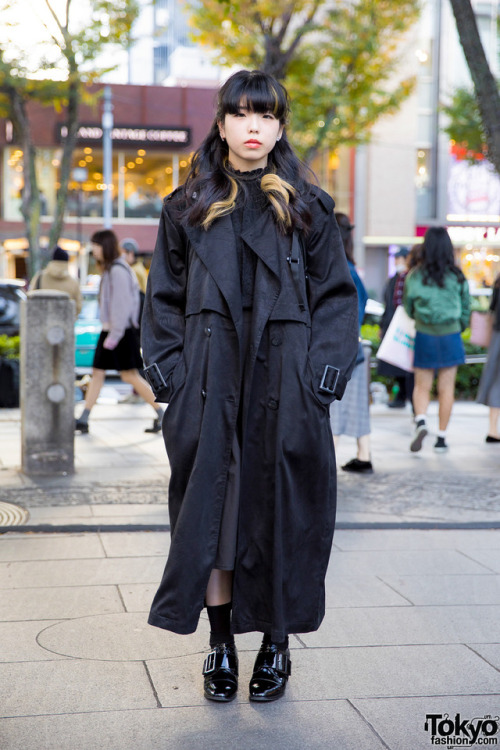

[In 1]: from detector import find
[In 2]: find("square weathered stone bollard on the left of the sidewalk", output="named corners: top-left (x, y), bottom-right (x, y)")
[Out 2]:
top-left (20, 289), bottom-right (75, 476)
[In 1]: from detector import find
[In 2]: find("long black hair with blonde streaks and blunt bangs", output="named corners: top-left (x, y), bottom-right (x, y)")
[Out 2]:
top-left (181, 70), bottom-right (312, 234)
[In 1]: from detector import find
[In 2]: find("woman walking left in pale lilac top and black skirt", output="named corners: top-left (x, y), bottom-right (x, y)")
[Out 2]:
top-left (75, 229), bottom-right (163, 434)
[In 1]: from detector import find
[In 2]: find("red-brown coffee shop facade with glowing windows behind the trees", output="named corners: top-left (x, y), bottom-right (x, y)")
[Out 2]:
top-left (0, 85), bottom-right (215, 278)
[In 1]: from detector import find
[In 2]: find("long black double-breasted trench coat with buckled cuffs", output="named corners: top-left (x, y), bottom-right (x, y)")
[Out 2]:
top-left (142, 188), bottom-right (358, 641)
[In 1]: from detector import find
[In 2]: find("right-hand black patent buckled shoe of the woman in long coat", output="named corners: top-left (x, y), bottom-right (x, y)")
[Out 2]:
top-left (250, 643), bottom-right (292, 702)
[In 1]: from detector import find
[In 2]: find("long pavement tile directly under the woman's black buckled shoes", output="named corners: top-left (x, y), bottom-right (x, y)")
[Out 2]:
top-left (148, 645), bottom-right (499, 712)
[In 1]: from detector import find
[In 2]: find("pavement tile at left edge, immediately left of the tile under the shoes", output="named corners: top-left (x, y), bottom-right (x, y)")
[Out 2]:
top-left (0, 660), bottom-right (157, 720)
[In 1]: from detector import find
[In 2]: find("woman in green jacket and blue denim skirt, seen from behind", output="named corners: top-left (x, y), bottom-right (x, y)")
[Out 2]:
top-left (403, 227), bottom-right (470, 453)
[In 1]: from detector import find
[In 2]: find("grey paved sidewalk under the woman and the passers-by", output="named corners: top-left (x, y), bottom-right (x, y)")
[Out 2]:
top-left (0, 396), bottom-right (500, 750)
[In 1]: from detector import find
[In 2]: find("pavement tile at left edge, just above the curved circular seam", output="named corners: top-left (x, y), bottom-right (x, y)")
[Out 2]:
top-left (0, 586), bottom-right (123, 621)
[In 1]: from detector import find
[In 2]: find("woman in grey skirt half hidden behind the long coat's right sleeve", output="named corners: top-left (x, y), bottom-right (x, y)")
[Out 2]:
top-left (330, 213), bottom-right (373, 474)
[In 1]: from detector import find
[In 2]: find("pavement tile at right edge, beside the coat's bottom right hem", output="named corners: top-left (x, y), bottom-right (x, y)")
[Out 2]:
top-left (300, 605), bottom-right (500, 648)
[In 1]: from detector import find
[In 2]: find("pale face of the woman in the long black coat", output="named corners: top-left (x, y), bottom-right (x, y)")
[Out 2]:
top-left (219, 102), bottom-right (283, 172)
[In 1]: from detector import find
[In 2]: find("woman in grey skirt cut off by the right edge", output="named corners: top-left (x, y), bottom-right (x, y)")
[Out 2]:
top-left (477, 276), bottom-right (500, 444)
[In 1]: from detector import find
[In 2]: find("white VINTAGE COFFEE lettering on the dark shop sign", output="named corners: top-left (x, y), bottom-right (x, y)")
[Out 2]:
top-left (56, 124), bottom-right (191, 148)
